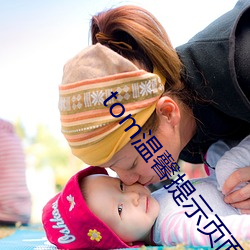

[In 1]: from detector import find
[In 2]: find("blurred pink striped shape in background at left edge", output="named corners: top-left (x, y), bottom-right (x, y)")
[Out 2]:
top-left (0, 119), bottom-right (31, 224)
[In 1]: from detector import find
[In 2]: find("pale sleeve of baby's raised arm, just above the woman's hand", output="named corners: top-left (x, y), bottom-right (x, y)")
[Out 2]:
top-left (215, 135), bottom-right (250, 190)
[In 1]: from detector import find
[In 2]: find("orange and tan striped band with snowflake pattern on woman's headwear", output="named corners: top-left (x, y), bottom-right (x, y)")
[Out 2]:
top-left (59, 70), bottom-right (164, 148)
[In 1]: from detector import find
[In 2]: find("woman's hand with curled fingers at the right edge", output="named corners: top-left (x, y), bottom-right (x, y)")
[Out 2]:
top-left (222, 166), bottom-right (250, 214)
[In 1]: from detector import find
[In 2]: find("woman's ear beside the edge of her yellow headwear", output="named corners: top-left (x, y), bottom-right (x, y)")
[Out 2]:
top-left (156, 96), bottom-right (180, 126)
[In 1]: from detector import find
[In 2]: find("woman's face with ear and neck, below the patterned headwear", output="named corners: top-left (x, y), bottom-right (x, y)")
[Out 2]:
top-left (101, 93), bottom-right (196, 186)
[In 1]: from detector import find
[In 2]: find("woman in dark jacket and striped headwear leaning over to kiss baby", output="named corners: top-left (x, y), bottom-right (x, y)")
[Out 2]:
top-left (60, 0), bottom-right (250, 211)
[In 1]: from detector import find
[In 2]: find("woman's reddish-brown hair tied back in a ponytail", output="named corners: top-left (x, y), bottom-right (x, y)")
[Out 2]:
top-left (91, 5), bottom-right (193, 131)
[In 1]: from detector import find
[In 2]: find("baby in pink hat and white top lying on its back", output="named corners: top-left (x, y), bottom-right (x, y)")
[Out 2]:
top-left (43, 138), bottom-right (250, 249)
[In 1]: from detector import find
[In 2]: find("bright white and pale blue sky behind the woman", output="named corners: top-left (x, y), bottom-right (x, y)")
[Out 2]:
top-left (0, 0), bottom-right (237, 137)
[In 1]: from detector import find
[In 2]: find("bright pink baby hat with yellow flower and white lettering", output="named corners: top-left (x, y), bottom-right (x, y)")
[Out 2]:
top-left (42, 167), bottom-right (142, 249)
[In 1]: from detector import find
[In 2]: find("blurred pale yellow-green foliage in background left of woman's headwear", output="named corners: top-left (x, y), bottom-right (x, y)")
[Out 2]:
top-left (14, 119), bottom-right (86, 191)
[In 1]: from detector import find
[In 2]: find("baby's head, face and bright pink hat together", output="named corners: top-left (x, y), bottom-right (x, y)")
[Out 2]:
top-left (43, 167), bottom-right (154, 249)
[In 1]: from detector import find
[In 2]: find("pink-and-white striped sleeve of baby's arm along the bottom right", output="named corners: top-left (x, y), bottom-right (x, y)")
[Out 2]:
top-left (160, 210), bottom-right (250, 246)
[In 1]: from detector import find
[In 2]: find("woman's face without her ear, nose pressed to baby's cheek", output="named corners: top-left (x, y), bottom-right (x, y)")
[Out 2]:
top-left (101, 119), bottom-right (181, 186)
